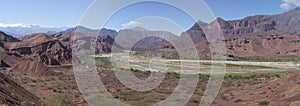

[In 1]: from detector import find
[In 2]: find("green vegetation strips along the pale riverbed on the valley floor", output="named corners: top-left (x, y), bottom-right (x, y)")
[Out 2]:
top-left (83, 56), bottom-right (300, 79)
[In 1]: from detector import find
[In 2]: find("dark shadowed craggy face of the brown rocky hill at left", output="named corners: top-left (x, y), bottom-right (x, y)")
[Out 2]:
top-left (10, 40), bottom-right (72, 65)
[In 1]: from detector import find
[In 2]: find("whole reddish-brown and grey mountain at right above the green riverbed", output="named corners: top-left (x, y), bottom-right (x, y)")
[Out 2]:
top-left (150, 8), bottom-right (300, 58)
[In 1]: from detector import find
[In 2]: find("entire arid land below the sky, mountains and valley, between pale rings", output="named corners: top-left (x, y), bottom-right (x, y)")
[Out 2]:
top-left (0, 8), bottom-right (300, 106)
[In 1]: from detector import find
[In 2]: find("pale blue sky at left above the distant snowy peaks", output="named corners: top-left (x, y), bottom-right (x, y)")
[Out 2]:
top-left (0, 0), bottom-right (93, 27)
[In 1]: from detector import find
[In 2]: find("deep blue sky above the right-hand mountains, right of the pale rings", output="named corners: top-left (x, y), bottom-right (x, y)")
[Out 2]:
top-left (204, 0), bottom-right (300, 20)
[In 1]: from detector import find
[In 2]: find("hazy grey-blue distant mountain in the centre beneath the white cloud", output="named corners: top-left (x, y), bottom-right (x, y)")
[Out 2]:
top-left (117, 27), bottom-right (178, 50)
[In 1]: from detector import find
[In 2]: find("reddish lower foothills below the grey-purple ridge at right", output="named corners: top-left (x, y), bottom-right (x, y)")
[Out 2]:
top-left (225, 33), bottom-right (300, 57)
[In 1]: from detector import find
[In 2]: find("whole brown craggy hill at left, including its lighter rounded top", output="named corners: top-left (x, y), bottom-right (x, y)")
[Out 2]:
top-left (6, 34), bottom-right (72, 65)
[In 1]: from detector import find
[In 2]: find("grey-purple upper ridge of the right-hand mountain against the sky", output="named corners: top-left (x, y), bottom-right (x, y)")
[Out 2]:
top-left (182, 8), bottom-right (300, 40)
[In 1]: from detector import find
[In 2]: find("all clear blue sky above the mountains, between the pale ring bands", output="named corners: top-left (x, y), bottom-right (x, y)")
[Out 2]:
top-left (0, 0), bottom-right (300, 30)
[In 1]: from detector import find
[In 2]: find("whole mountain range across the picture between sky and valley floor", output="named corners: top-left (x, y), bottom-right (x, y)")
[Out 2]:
top-left (0, 8), bottom-right (300, 70)
